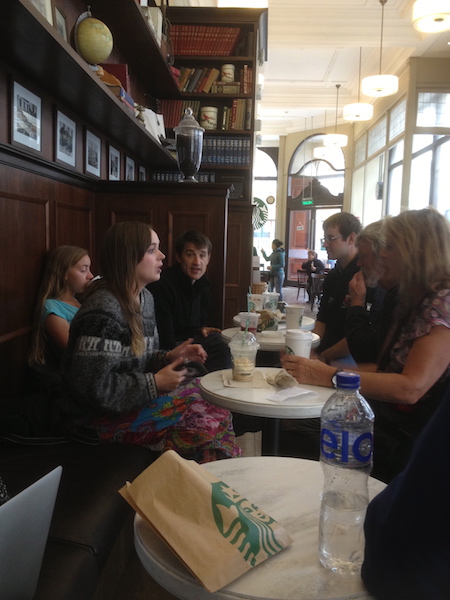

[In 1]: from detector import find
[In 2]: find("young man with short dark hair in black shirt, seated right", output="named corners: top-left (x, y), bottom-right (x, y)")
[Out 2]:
top-left (314, 212), bottom-right (362, 364)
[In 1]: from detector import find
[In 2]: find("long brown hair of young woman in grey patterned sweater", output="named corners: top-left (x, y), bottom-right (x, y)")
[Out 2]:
top-left (98, 221), bottom-right (152, 356)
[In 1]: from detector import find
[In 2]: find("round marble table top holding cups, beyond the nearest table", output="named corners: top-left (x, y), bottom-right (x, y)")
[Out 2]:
top-left (200, 367), bottom-right (334, 419)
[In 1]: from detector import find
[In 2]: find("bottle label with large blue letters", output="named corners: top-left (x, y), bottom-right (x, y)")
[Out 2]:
top-left (320, 427), bottom-right (373, 465)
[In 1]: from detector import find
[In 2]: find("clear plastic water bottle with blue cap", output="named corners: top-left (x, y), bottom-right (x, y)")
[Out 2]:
top-left (319, 372), bottom-right (374, 574)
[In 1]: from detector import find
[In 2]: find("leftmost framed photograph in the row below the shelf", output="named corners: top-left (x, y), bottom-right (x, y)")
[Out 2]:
top-left (12, 82), bottom-right (41, 151)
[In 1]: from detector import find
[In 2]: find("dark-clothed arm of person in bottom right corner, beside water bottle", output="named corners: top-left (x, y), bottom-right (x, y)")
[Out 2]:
top-left (361, 387), bottom-right (450, 600)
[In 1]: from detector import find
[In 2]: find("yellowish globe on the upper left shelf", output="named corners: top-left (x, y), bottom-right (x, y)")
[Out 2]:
top-left (75, 17), bottom-right (113, 65)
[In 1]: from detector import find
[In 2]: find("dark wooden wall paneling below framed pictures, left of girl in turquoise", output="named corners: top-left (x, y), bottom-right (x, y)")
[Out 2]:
top-left (0, 159), bottom-right (94, 397)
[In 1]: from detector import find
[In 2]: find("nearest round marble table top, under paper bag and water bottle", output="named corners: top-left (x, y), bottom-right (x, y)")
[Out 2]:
top-left (135, 457), bottom-right (385, 600)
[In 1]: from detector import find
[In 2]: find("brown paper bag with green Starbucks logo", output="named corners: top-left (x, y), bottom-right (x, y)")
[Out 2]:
top-left (119, 450), bottom-right (292, 592)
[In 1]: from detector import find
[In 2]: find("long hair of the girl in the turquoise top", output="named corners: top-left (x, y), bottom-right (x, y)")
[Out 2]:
top-left (28, 246), bottom-right (89, 365)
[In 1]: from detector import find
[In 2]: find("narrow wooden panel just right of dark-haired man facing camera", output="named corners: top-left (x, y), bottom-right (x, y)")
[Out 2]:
top-left (224, 201), bottom-right (253, 327)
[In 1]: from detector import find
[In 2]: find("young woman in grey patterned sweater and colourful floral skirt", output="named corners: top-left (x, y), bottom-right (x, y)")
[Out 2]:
top-left (63, 222), bottom-right (240, 462)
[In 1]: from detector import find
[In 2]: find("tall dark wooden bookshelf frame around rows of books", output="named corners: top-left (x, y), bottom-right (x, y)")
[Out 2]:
top-left (163, 7), bottom-right (265, 203)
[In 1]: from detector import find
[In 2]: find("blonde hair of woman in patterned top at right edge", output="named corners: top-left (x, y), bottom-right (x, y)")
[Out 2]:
top-left (382, 207), bottom-right (450, 308)
